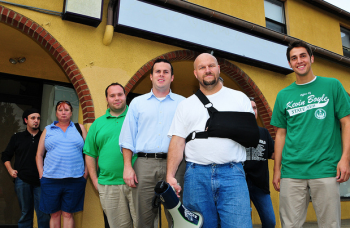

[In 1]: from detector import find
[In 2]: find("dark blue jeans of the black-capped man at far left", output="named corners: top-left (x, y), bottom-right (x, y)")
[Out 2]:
top-left (15, 177), bottom-right (50, 228)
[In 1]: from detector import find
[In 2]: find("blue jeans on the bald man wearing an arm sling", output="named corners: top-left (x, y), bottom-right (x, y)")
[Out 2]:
top-left (183, 162), bottom-right (252, 228)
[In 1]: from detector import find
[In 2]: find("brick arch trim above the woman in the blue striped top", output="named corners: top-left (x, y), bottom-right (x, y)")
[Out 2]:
top-left (0, 5), bottom-right (95, 124)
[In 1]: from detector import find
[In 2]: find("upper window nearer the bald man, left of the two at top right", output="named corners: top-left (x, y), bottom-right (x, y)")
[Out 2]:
top-left (264, 0), bottom-right (286, 33)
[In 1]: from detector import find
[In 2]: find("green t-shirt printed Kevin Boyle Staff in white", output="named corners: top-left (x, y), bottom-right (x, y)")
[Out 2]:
top-left (271, 76), bottom-right (350, 179)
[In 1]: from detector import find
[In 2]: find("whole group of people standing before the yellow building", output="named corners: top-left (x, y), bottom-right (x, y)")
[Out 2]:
top-left (2, 41), bottom-right (350, 228)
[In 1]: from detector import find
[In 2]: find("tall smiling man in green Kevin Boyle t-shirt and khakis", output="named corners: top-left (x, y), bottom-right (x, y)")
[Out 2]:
top-left (271, 41), bottom-right (350, 228)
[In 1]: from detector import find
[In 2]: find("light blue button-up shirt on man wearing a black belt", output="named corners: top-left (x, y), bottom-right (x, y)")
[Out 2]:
top-left (119, 91), bottom-right (185, 153)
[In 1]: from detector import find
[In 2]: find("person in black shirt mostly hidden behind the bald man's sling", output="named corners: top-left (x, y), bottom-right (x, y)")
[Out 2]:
top-left (244, 97), bottom-right (276, 228)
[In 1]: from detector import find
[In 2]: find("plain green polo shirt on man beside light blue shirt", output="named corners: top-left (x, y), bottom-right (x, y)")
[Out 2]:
top-left (83, 106), bottom-right (137, 185)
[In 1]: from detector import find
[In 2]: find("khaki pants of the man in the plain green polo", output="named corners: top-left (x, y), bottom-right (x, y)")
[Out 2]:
top-left (98, 184), bottom-right (136, 228)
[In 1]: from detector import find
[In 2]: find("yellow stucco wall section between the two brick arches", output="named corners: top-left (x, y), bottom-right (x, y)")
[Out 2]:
top-left (0, 1), bottom-right (185, 117)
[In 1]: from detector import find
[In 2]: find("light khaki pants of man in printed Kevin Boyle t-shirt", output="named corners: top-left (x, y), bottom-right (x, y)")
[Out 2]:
top-left (280, 177), bottom-right (341, 228)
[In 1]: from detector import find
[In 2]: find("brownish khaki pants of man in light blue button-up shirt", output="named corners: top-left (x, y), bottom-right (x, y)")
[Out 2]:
top-left (132, 157), bottom-right (186, 228)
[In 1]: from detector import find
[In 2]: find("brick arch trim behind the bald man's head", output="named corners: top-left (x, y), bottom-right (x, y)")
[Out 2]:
top-left (125, 50), bottom-right (276, 138)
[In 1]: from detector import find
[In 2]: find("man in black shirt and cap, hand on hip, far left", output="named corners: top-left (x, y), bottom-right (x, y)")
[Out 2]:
top-left (1, 108), bottom-right (50, 228)
